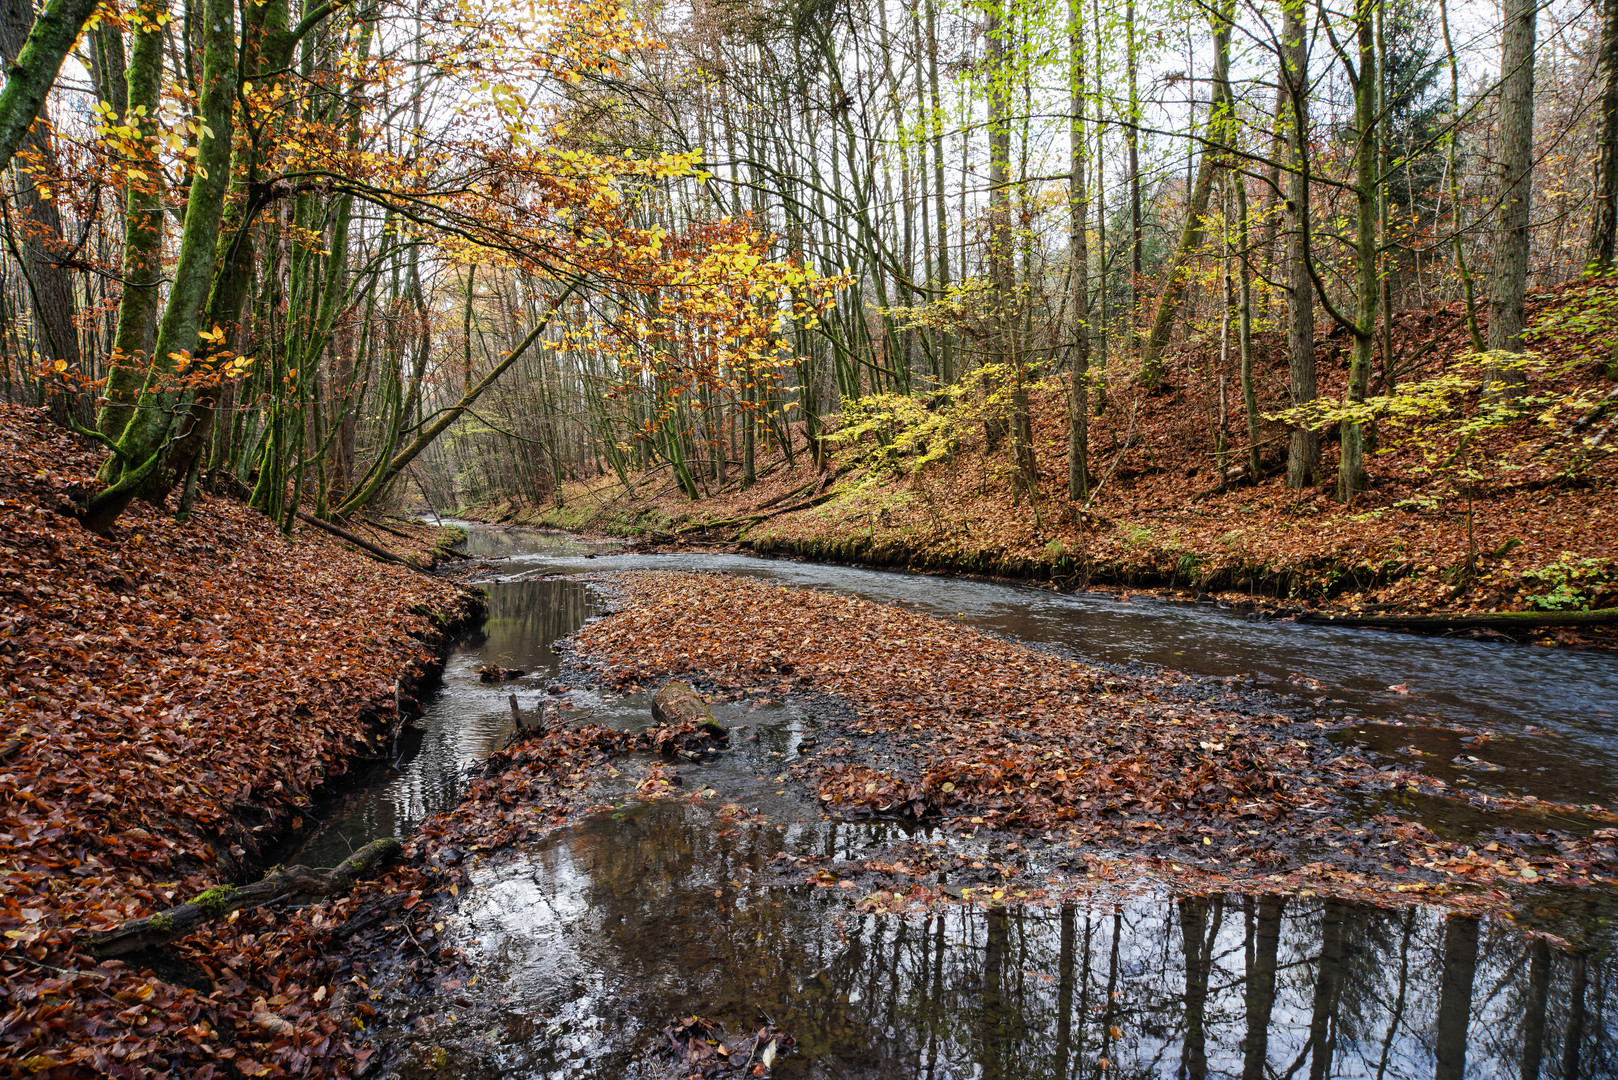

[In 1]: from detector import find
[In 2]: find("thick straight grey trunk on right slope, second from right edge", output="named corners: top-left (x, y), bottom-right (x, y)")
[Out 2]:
top-left (1489, 0), bottom-right (1539, 362)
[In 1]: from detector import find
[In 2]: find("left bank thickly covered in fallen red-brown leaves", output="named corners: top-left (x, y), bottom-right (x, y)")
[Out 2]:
top-left (0, 406), bottom-right (476, 1077)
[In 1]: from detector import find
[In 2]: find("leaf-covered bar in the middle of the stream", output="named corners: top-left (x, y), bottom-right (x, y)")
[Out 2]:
top-left (578, 573), bottom-right (1618, 907)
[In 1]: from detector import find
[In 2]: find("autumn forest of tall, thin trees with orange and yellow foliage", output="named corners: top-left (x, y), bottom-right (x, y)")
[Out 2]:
top-left (0, 0), bottom-right (1618, 563)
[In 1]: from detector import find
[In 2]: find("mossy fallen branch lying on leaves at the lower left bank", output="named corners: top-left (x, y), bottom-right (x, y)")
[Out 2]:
top-left (81, 837), bottom-right (403, 957)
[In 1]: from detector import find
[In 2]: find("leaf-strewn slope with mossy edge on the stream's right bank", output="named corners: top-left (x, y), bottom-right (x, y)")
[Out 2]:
top-left (475, 279), bottom-right (1618, 648)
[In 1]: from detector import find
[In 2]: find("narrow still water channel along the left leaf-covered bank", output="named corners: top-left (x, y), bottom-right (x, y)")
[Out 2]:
top-left (290, 581), bottom-right (597, 866)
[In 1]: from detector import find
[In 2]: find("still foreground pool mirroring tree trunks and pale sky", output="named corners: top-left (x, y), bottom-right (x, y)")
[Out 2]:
top-left (430, 803), bottom-right (1618, 1080)
